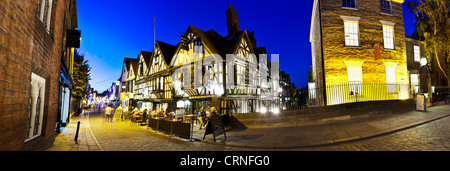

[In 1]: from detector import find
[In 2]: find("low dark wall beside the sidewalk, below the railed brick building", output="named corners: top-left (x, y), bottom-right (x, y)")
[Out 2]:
top-left (230, 99), bottom-right (415, 128)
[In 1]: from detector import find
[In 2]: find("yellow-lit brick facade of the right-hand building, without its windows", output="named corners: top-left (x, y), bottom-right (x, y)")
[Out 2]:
top-left (320, 0), bottom-right (408, 84)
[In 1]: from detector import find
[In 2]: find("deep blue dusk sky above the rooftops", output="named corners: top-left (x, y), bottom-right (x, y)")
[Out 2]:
top-left (77, 0), bottom-right (414, 93)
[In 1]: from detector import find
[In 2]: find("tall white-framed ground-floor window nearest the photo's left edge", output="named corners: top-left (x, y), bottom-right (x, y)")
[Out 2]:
top-left (25, 73), bottom-right (45, 141)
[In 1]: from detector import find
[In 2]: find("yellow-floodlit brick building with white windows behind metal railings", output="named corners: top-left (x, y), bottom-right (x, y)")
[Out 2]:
top-left (310, 0), bottom-right (409, 106)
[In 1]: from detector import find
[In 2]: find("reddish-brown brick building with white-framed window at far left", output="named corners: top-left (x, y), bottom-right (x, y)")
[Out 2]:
top-left (0, 0), bottom-right (76, 150)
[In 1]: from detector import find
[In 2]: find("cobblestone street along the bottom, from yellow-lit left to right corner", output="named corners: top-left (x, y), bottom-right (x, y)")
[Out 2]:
top-left (48, 108), bottom-right (450, 151)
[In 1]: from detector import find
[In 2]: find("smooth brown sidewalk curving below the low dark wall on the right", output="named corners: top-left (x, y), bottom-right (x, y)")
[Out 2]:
top-left (200, 105), bottom-right (450, 149)
